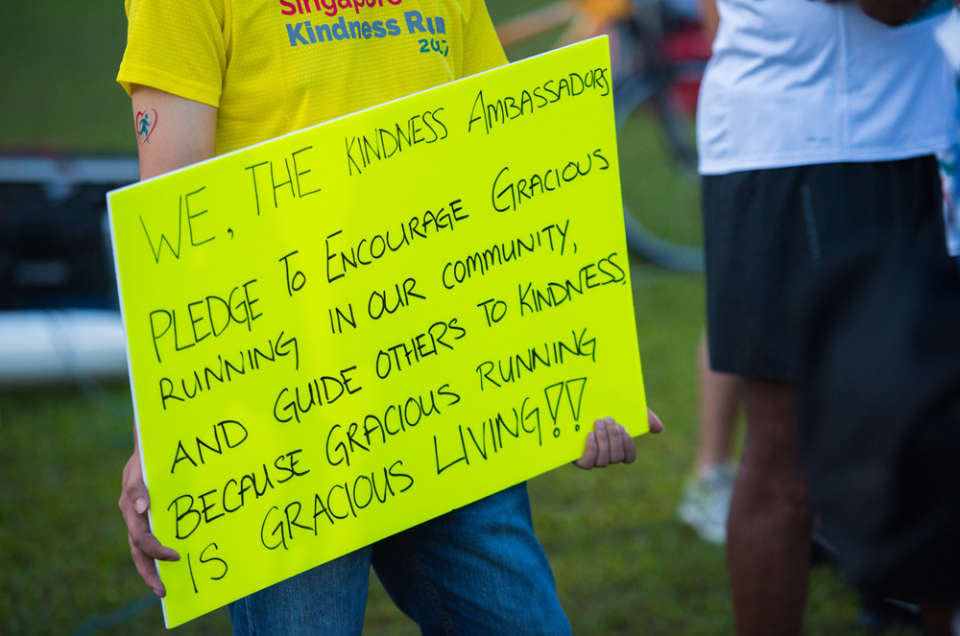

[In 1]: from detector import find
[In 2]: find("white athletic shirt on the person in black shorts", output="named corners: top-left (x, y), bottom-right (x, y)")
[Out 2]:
top-left (697, 0), bottom-right (957, 174)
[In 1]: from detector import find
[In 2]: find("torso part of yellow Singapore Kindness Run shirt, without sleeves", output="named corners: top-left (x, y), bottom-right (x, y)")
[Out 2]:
top-left (217, 0), bottom-right (498, 154)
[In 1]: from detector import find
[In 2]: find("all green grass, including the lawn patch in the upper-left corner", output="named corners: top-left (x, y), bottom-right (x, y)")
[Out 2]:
top-left (0, 0), bottom-right (914, 635)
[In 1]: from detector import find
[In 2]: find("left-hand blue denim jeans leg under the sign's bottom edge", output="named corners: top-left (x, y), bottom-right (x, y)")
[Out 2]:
top-left (230, 547), bottom-right (371, 636)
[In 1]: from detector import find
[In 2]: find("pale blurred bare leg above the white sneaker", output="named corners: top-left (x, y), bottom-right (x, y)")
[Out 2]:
top-left (696, 335), bottom-right (743, 477)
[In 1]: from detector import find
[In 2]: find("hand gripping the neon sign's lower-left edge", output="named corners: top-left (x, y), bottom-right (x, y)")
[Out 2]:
top-left (117, 445), bottom-right (180, 596)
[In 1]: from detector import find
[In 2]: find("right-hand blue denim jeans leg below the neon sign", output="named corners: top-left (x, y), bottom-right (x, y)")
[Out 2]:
top-left (373, 484), bottom-right (570, 636)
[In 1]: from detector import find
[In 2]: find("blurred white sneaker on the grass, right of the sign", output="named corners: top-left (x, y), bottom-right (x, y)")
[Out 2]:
top-left (677, 463), bottom-right (737, 545)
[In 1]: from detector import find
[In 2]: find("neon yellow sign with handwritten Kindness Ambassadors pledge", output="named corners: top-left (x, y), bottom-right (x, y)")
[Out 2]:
top-left (109, 39), bottom-right (646, 626)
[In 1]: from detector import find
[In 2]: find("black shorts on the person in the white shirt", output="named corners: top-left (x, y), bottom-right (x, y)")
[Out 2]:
top-left (703, 156), bottom-right (946, 381)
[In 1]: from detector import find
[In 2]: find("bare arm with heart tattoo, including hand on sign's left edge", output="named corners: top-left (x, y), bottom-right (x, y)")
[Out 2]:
top-left (117, 86), bottom-right (217, 596)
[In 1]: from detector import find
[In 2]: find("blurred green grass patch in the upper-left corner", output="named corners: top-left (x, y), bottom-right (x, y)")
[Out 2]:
top-left (0, 0), bottom-right (136, 154)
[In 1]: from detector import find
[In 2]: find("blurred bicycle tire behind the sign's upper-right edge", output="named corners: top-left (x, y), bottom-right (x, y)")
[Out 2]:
top-left (614, 76), bottom-right (704, 273)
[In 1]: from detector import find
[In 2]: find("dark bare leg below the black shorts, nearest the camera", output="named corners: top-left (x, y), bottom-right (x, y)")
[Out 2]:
top-left (727, 379), bottom-right (812, 636)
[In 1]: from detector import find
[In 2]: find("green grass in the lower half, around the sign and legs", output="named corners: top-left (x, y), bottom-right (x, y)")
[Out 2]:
top-left (0, 261), bottom-right (920, 635)
